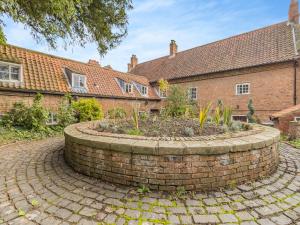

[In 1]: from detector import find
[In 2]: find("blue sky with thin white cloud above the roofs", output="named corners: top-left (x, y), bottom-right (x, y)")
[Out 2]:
top-left (5, 0), bottom-right (290, 71)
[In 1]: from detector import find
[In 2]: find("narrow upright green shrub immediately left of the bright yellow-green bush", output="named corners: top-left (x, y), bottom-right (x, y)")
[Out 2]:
top-left (57, 94), bottom-right (76, 127)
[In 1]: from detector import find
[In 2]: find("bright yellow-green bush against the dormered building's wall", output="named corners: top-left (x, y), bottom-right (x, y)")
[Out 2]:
top-left (72, 98), bottom-right (104, 122)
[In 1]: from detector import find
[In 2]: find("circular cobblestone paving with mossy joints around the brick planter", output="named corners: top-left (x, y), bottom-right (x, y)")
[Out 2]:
top-left (0, 138), bottom-right (300, 225)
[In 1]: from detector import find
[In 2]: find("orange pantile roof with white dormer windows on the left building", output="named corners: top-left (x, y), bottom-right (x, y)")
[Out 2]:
top-left (0, 45), bottom-right (158, 99)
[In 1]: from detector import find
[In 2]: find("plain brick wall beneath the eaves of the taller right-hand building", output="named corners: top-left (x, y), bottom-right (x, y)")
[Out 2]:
top-left (157, 63), bottom-right (300, 122)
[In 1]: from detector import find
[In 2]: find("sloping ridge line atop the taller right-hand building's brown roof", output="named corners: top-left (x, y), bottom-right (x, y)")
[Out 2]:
top-left (137, 21), bottom-right (289, 66)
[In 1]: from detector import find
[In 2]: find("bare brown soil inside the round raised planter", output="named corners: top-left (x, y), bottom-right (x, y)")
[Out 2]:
top-left (96, 117), bottom-right (245, 137)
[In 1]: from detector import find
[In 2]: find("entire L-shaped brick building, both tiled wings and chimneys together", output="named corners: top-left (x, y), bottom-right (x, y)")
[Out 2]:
top-left (0, 0), bottom-right (300, 130)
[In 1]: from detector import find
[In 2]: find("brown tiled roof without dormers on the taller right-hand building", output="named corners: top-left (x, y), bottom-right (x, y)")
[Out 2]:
top-left (131, 22), bottom-right (296, 81)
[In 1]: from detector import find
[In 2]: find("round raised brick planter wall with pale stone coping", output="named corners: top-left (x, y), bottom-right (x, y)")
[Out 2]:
top-left (64, 122), bottom-right (280, 191)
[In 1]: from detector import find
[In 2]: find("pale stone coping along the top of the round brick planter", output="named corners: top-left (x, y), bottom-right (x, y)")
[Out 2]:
top-left (65, 122), bottom-right (280, 155)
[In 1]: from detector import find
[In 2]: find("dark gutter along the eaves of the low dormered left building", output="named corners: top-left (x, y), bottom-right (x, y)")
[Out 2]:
top-left (0, 88), bottom-right (161, 101)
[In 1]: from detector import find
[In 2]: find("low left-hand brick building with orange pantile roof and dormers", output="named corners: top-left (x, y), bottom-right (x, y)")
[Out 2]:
top-left (0, 45), bottom-right (160, 119)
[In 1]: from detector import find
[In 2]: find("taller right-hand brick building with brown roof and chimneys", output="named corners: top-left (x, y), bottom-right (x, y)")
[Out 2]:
top-left (128, 0), bottom-right (300, 123)
